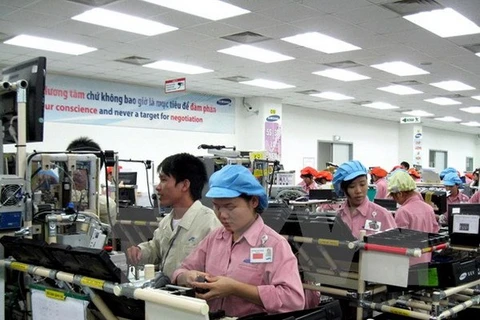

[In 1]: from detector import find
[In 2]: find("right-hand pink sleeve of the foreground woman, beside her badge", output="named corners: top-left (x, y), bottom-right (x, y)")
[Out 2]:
top-left (257, 240), bottom-right (305, 313)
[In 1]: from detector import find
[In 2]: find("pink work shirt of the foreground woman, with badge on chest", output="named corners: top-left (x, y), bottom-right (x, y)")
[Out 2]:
top-left (173, 216), bottom-right (305, 317)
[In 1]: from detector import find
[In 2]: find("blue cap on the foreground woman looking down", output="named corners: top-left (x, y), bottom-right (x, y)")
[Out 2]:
top-left (206, 164), bottom-right (268, 210)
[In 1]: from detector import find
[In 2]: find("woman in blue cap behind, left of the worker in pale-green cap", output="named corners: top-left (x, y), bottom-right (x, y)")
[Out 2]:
top-left (333, 160), bottom-right (397, 238)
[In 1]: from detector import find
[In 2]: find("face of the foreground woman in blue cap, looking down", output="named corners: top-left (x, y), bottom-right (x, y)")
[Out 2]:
top-left (212, 197), bottom-right (258, 235)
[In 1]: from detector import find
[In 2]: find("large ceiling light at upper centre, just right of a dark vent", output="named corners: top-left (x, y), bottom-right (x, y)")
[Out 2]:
top-left (282, 32), bottom-right (362, 53)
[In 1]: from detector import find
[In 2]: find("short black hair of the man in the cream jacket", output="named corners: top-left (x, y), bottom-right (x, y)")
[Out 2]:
top-left (157, 153), bottom-right (208, 201)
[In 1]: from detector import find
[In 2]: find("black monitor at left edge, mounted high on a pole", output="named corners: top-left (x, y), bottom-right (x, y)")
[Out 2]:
top-left (0, 57), bottom-right (47, 144)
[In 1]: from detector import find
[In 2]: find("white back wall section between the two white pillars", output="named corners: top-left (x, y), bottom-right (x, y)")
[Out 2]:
top-left (282, 105), bottom-right (398, 182)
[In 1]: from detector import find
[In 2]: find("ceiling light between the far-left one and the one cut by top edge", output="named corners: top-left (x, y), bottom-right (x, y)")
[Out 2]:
top-left (72, 8), bottom-right (178, 36)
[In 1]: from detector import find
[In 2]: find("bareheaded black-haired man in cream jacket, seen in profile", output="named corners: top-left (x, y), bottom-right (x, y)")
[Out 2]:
top-left (127, 153), bottom-right (220, 278)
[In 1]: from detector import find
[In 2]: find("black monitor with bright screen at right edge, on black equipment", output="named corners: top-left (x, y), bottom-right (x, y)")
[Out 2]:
top-left (448, 203), bottom-right (480, 247)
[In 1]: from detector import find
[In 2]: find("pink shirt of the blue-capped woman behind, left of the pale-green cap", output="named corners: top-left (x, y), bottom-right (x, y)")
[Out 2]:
top-left (338, 197), bottom-right (397, 238)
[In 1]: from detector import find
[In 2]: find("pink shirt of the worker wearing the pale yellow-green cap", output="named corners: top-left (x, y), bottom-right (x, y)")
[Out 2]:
top-left (395, 192), bottom-right (440, 265)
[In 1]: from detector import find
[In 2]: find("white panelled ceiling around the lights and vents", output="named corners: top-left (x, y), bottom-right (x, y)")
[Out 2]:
top-left (0, 0), bottom-right (480, 134)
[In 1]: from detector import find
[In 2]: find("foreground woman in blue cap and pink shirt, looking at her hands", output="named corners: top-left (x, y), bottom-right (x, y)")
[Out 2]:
top-left (173, 165), bottom-right (305, 317)
